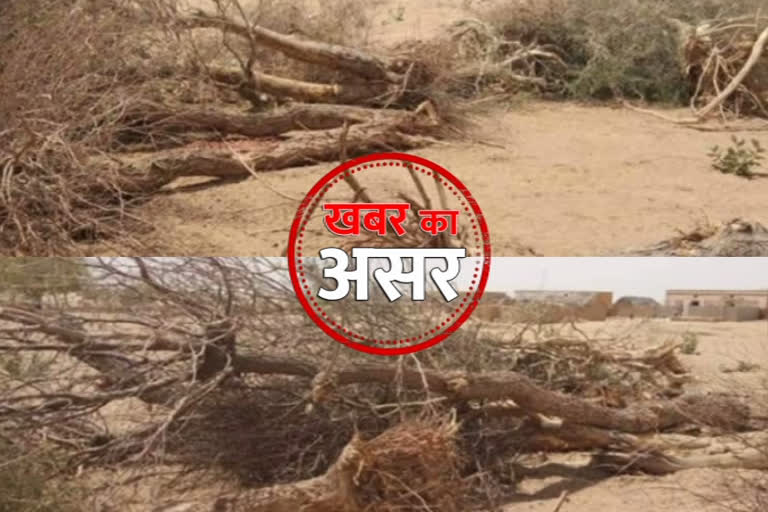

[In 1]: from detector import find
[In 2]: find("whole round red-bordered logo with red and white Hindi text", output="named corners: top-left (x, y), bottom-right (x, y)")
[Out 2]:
top-left (288, 153), bottom-right (491, 355)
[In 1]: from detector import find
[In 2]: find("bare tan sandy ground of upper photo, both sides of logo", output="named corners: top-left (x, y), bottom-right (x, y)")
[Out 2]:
top-left (136, 103), bottom-right (768, 256)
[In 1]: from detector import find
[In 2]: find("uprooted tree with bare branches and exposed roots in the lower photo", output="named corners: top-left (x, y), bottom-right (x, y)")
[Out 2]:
top-left (0, 258), bottom-right (768, 511)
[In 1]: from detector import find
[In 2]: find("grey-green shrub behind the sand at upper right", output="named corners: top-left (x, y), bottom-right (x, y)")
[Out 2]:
top-left (472, 0), bottom-right (763, 103)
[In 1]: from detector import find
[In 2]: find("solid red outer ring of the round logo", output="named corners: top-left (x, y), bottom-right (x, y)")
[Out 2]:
top-left (287, 153), bottom-right (491, 356)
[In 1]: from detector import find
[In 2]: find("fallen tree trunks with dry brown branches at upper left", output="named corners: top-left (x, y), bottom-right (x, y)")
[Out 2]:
top-left (0, 0), bottom-right (450, 254)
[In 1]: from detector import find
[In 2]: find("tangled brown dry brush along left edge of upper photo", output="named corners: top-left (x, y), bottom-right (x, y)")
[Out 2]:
top-left (0, 0), bottom-right (182, 255)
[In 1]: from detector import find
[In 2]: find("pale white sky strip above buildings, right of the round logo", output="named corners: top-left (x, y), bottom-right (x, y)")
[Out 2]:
top-left (474, 258), bottom-right (768, 301)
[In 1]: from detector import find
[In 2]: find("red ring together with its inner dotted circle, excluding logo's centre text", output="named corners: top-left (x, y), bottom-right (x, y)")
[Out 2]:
top-left (289, 153), bottom-right (490, 355)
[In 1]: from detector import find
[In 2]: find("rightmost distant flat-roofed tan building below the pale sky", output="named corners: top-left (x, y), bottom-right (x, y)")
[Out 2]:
top-left (666, 290), bottom-right (768, 322)
